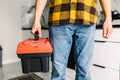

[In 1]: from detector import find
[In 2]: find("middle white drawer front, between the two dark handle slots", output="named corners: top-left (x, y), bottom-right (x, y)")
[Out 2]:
top-left (92, 42), bottom-right (120, 70)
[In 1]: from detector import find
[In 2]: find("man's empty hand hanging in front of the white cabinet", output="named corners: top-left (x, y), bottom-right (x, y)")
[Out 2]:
top-left (103, 21), bottom-right (113, 39)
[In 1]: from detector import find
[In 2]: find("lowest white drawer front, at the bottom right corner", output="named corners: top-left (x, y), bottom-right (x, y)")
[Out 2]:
top-left (91, 66), bottom-right (119, 80)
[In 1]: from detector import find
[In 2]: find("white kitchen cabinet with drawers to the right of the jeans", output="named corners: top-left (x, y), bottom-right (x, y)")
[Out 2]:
top-left (91, 28), bottom-right (120, 80)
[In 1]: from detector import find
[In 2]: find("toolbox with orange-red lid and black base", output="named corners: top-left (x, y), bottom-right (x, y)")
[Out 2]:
top-left (16, 38), bottom-right (53, 73)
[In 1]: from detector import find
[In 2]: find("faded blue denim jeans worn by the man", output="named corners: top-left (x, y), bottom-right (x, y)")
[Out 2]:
top-left (49, 24), bottom-right (95, 80)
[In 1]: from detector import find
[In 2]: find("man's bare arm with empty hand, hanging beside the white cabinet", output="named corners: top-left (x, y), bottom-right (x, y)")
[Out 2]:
top-left (100, 0), bottom-right (113, 39)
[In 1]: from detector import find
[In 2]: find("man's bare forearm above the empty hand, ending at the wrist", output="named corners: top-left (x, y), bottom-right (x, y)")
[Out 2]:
top-left (100, 0), bottom-right (112, 21)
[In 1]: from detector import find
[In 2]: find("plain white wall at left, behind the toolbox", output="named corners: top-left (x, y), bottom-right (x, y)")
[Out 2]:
top-left (0, 0), bottom-right (31, 64)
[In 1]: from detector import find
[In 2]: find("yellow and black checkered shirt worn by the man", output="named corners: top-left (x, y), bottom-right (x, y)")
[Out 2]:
top-left (49, 0), bottom-right (98, 25)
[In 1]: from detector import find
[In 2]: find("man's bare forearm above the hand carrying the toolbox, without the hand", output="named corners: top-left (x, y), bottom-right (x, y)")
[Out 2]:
top-left (34, 0), bottom-right (47, 23)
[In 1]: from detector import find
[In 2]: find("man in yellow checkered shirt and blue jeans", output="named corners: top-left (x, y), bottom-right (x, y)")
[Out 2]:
top-left (32, 0), bottom-right (112, 80)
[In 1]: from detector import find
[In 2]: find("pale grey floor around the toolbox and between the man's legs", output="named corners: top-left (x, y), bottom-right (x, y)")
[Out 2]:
top-left (0, 62), bottom-right (75, 80)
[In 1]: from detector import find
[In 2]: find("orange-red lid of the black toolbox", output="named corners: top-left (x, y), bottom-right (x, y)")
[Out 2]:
top-left (16, 38), bottom-right (53, 54)
